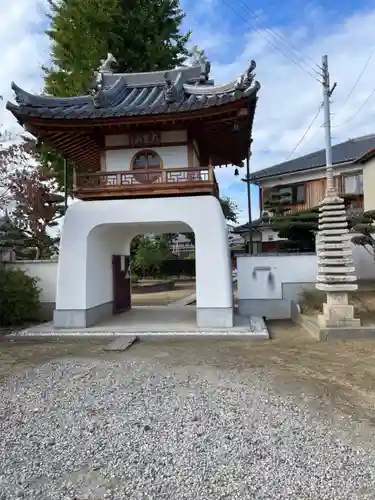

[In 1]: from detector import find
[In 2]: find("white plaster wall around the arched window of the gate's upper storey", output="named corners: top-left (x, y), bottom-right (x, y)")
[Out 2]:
top-left (105, 130), bottom-right (188, 172)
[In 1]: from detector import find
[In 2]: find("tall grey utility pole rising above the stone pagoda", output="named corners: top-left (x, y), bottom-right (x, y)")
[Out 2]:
top-left (322, 56), bottom-right (336, 196)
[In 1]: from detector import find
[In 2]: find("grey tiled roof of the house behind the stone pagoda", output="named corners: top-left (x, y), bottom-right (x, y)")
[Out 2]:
top-left (250, 134), bottom-right (375, 182)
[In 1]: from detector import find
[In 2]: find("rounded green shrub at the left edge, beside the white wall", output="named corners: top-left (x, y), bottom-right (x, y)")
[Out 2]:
top-left (0, 268), bottom-right (40, 326)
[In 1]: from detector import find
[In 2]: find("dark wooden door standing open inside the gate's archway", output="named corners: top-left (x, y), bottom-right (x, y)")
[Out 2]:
top-left (112, 255), bottom-right (131, 314)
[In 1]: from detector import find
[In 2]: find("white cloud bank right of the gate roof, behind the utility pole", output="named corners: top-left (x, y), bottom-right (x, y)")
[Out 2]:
top-left (184, 4), bottom-right (375, 221)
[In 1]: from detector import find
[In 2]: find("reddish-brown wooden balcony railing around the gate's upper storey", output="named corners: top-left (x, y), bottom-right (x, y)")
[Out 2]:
top-left (75, 167), bottom-right (219, 198)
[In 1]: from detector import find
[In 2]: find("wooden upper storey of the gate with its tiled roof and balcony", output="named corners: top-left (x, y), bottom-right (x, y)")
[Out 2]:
top-left (7, 51), bottom-right (260, 199)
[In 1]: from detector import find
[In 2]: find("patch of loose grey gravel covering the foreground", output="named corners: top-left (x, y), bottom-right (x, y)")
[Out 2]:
top-left (0, 359), bottom-right (375, 500)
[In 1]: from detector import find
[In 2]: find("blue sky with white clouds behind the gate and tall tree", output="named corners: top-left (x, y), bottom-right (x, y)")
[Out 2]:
top-left (0, 0), bottom-right (375, 223)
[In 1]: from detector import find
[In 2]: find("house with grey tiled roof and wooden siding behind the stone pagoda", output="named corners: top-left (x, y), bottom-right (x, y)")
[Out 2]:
top-left (236, 134), bottom-right (375, 253)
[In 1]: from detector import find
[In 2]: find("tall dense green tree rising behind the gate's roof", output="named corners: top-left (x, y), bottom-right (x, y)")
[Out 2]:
top-left (43, 0), bottom-right (190, 191)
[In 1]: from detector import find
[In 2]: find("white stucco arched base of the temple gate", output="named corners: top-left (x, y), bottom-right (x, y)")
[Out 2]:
top-left (56, 196), bottom-right (232, 310)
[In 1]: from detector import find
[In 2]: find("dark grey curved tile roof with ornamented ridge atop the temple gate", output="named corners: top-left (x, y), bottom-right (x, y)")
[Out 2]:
top-left (7, 57), bottom-right (260, 119)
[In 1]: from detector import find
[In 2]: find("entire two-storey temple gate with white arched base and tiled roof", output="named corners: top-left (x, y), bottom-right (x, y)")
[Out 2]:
top-left (7, 51), bottom-right (260, 329)
